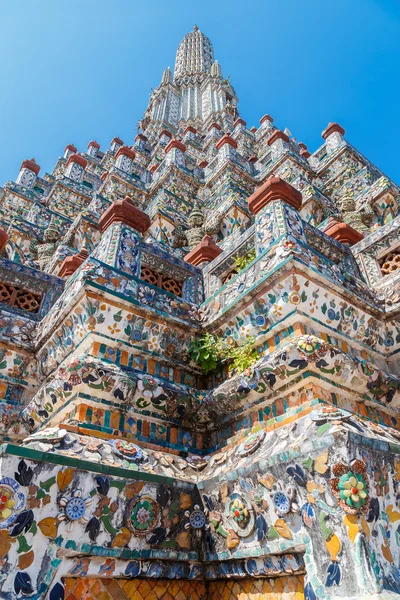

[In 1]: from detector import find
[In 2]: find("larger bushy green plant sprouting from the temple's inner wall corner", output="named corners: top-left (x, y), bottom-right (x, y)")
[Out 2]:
top-left (189, 333), bottom-right (259, 375)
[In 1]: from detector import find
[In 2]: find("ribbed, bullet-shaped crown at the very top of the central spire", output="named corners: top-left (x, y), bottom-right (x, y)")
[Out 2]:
top-left (174, 25), bottom-right (214, 79)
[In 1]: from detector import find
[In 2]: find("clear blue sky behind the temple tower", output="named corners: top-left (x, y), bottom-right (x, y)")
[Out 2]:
top-left (0, 0), bottom-right (400, 185)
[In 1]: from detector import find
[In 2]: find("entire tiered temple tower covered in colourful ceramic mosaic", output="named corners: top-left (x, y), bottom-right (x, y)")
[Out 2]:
top-left (0, 27), bottom-right (400, 600)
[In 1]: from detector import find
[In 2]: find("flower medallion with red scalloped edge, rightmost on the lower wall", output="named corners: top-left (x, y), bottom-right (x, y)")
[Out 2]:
top-left (329, 460), bottom-right (369, 515)
